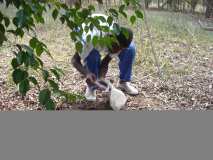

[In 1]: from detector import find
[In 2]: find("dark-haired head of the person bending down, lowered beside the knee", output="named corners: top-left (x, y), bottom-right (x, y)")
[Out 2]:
top-left (110, 27), bottom-right (133, 53)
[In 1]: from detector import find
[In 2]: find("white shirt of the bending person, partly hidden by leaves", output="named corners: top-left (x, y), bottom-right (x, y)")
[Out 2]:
top-left (80, 14), bottom-right (113, 61)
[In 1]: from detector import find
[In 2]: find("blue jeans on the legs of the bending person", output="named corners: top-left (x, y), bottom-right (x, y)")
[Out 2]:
top-left (85, 42), bottom-right (136, 82)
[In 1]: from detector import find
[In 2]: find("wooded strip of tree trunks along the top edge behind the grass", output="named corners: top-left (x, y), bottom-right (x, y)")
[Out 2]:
top-left (62, 0), bottom-right (213, 18)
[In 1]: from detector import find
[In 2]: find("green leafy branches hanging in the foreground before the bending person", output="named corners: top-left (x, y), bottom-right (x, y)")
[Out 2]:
top-left (0, 0), bottom-right (143, 110)
